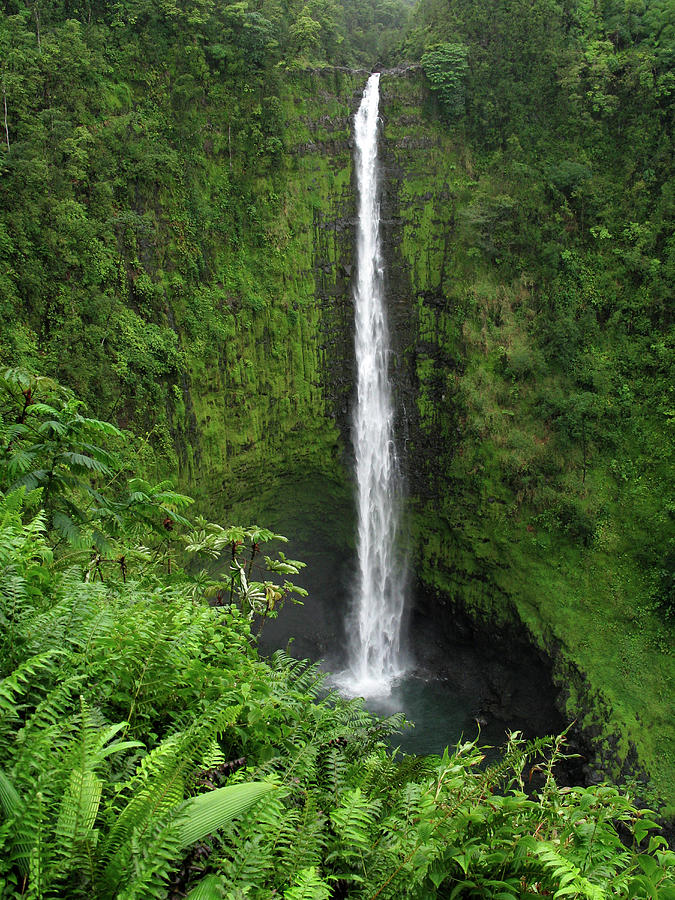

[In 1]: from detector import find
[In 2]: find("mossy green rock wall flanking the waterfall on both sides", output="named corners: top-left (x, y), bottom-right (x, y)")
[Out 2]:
top-left (174, 68), bottom-right (675, 800)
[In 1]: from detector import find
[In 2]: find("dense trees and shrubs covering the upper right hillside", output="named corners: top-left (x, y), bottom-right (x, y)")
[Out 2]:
top-left (408, 0), bottom-right (675, 620)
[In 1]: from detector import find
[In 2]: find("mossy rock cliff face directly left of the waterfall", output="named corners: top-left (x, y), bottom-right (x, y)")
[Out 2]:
top-left (174, 73), bottom-right (362, 514)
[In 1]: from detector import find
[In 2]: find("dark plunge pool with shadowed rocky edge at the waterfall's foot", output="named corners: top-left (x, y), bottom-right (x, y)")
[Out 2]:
top-left (260, 605), bottom-right (564, 758)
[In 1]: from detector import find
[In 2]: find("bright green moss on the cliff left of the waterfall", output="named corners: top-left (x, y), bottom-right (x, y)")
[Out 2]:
top-left (166, 74), bottom-right (362, 510)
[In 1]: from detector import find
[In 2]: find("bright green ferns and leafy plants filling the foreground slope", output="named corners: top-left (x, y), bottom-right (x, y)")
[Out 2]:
top-left (0, 370), bottom-right (675, 900)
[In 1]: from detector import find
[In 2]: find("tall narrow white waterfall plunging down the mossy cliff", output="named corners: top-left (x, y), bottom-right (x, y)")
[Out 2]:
top-left (345, 73), bottom-right (405, 695)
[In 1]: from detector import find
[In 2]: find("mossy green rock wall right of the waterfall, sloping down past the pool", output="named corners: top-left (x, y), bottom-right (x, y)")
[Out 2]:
top-left (381, 69), bottom-right (675, 803)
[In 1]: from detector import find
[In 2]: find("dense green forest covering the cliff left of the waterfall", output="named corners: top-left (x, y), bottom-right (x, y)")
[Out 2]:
top-left (0, 0), bottom-right (407, 486)
